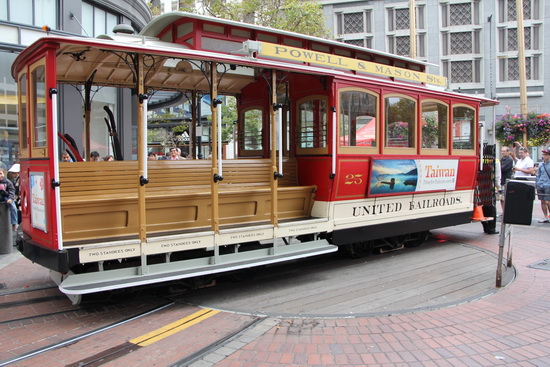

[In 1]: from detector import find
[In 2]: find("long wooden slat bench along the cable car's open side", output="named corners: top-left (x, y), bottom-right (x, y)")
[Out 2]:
top-left (60, 159), bottom-right (316, 245)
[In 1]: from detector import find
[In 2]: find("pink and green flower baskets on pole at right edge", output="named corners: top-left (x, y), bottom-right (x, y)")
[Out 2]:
top-left (495, 113), bottom-right (550, 146)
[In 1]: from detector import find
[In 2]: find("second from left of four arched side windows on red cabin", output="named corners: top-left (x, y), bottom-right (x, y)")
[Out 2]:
top-left (385, 97), bottom-right (416, 148)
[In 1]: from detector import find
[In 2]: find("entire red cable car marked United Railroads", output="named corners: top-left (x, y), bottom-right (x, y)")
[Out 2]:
top-left (12, 13), bottom-right (496, 302)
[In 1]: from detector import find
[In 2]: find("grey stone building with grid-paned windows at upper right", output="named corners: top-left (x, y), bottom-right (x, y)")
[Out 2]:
top-left (320, 0), bottom-right (550, 150)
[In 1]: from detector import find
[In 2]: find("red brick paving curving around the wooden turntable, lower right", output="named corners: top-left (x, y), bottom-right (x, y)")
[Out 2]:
top-left (192, 206), bottom-right (550, 367)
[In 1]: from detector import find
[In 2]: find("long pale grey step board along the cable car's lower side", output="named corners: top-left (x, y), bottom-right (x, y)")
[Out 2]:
top-left (59, 240), bottom-right (338, 295)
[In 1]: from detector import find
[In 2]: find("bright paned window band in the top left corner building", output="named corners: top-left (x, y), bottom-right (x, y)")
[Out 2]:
top-left (0, 0), bottom-right (58, 29)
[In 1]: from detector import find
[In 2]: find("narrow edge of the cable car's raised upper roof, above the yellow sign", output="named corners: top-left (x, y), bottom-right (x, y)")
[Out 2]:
top-left (140, 12), bottom-right (439, 67)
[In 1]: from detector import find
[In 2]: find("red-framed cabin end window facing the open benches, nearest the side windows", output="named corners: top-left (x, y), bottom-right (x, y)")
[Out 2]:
top-left (297, 99), bottom-right (327, 148)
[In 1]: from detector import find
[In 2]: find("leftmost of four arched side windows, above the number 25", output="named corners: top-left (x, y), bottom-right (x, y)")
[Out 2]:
top-left (340, 91), bottom-right (378, 147)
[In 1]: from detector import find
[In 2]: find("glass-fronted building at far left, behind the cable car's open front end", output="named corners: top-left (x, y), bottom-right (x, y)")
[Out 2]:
top-left (0, 0), bottom-right (152, 168)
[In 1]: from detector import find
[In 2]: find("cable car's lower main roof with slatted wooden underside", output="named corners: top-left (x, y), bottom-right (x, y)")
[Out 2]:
top-left (12, 26), bottom-right (498, 106)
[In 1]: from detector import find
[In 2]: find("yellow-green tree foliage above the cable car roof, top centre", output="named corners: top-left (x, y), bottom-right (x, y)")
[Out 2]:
top-left (204, 0), bottom-right (328, 38)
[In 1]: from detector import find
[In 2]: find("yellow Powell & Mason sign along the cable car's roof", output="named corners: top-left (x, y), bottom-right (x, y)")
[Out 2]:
top-left (249, 41), bottom-right (447, 87)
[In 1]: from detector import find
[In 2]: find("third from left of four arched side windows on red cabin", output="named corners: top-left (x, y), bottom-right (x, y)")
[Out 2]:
top-left (421, 101), bottom-right (449, 149)
